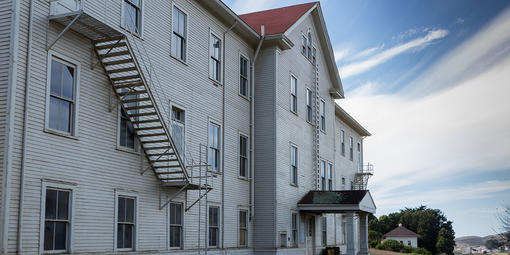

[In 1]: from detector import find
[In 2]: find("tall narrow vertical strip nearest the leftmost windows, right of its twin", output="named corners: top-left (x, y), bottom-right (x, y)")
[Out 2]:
top-left (18, 0), bottom-right (34, 254)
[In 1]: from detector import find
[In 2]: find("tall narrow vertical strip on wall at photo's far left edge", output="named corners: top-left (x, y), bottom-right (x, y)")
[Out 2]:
top-left (0, 0), bottom-right (20, 254)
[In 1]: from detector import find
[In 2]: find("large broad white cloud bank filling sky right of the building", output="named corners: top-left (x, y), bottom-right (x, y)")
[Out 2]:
top-left (340, 6), bottom-right (510, 213)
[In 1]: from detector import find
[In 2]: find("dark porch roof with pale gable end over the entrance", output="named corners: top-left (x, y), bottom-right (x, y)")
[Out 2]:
top-left (298, 190), bottom-right (376, 213)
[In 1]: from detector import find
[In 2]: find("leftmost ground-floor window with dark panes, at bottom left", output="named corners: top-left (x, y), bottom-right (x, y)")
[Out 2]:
top-left (44, 188), bottom-right (71, 251)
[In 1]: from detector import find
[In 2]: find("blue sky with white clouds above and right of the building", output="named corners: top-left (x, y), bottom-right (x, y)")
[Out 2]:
top-left (225, 0), bottom-right (510, 236)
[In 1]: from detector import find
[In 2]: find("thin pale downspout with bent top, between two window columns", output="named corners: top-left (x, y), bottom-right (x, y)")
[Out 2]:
top-left (219, 20), bottom-right (237, 249)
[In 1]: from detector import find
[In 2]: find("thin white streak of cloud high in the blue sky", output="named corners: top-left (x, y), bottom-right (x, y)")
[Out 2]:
top-left (340, 29), bottom-right (448, 78)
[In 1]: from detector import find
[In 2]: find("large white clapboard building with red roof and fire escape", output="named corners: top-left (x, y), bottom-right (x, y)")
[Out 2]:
top-left (0, 0), bottom-right (375, 255)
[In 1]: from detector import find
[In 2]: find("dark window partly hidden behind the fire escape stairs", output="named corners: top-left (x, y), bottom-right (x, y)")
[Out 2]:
top-left (119, 89), bottom-right (138, 151)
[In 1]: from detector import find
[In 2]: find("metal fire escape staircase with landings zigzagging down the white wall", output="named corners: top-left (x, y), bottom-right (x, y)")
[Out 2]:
top-left (47, 0), bottom-right (211, 204)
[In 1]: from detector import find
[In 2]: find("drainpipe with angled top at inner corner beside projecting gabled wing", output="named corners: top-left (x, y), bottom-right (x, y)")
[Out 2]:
top-left (250, 25), bottom-right (265, 221)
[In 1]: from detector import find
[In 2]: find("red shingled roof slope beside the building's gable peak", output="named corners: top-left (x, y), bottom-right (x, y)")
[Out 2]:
top-left (239, 2), bottom-right (317, 35)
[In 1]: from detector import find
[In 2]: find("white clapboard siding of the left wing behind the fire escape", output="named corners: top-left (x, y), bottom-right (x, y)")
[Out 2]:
top-left (5, 0), bottom-right (253, 254)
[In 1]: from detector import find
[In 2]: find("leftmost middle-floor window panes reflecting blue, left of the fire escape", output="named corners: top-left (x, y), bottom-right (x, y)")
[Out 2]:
top-left (48, 59), bottom-right (76, 134)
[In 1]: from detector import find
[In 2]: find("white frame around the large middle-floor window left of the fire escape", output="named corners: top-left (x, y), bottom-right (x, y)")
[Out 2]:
top-left (44, 50), bottom-right (81, 139)
